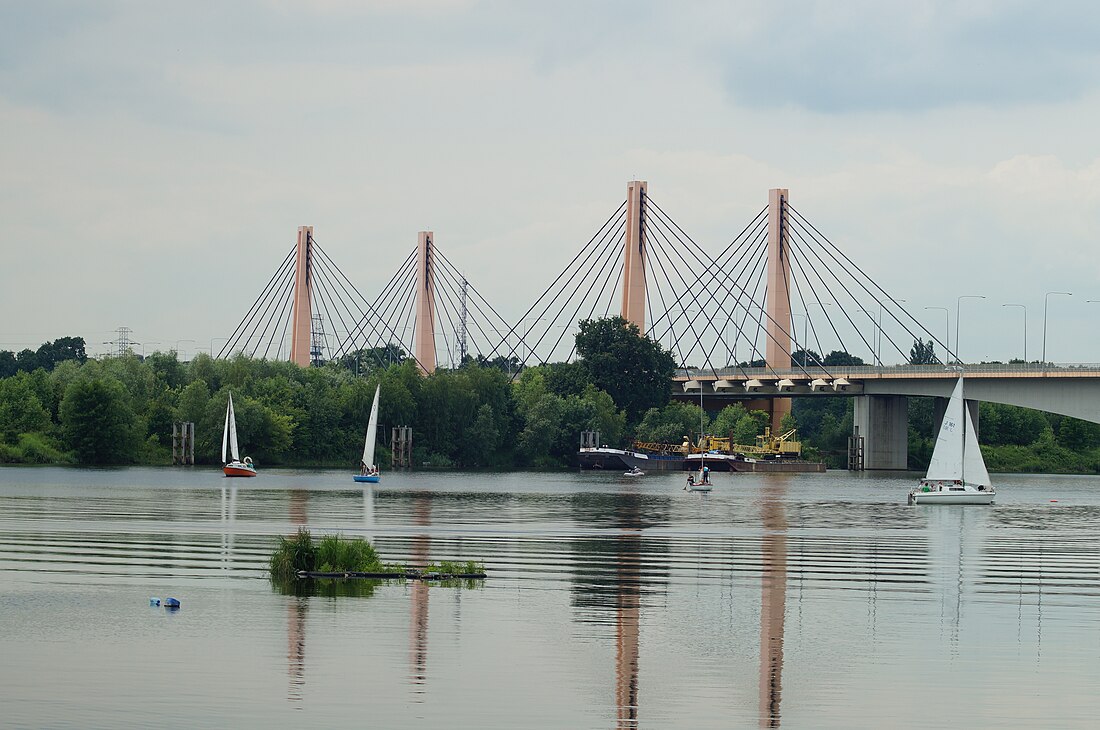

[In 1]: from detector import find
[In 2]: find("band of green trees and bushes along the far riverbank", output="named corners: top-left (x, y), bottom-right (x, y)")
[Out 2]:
top-left (0, 325), bottom-right (1100, 473)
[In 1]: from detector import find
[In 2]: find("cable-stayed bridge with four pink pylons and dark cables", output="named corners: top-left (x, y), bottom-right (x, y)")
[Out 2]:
top-left (219, 180), bottom-right (1100, 468)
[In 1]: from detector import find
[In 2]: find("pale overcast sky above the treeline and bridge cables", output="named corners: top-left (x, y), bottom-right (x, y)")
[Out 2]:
top-left (0, 0), bottom-right (1100, 362)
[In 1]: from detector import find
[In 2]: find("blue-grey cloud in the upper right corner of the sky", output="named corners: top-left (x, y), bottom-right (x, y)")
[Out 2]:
top-left (712, 2), bottom-right (1100, 114)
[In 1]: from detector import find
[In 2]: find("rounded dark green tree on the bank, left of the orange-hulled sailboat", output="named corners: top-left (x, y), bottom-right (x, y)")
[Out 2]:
top-left (61, 378), bottom-right (144, 464)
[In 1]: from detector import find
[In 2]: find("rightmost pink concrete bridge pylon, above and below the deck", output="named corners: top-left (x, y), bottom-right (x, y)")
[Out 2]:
top-left (765, 188), bottom-right (791, 433)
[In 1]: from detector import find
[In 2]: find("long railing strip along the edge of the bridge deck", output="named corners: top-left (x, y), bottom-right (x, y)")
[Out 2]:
top-left (673, 363), bottom-right (1100, 380)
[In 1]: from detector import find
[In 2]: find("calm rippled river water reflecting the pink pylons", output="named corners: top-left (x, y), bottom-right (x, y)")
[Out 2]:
top-left (0, 468), bottom-right (1100, 728)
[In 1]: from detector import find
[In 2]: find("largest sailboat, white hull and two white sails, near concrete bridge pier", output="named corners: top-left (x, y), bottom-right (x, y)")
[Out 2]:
top-left (909, 375), bottom-right (997, 505)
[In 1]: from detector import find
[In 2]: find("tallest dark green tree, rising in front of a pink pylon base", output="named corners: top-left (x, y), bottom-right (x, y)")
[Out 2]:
top-left (576, 317), bottom-right (675, 420)
